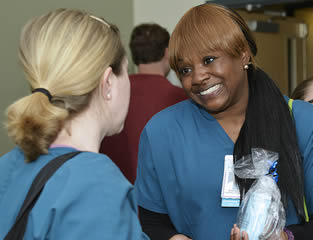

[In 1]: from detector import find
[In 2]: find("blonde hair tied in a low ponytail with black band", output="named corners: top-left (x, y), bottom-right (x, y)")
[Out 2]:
top-left (6, 9), bottom-right (125, 161)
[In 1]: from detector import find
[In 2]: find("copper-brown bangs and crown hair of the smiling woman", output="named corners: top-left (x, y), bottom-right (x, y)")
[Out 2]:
top-left (169, 4), bottom-right (257, 73)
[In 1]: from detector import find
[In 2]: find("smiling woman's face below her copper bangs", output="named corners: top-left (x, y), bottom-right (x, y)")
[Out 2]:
top-left (175, 51), bottom-right (249, 118)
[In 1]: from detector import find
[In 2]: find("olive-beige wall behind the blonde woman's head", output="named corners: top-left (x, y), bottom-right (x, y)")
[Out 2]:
top-left (0, 0), bottom-right (133, 155)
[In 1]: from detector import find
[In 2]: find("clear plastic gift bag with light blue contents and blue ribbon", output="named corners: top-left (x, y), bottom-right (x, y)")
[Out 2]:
top-left (234, 148), bottom-right (286, 240)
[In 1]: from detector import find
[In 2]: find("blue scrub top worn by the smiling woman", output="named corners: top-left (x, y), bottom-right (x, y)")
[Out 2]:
top-left (135, 100), bottom-right (313, 240)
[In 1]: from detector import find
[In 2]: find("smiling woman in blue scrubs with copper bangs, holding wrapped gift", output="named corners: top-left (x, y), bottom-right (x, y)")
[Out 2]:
top-left (135, 3), bottom-right (313, 240)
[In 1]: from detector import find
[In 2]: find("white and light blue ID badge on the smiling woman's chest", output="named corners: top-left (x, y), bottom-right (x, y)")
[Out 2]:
top-left (221, 155), bottom-right (240, 207)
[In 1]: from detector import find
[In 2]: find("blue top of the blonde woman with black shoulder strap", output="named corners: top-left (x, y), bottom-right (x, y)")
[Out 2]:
top-left (0, 148), bottom-right (148, 240)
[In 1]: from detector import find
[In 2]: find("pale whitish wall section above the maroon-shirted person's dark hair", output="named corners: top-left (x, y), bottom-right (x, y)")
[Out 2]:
top-left (133, 0), bottom-right (205, 86)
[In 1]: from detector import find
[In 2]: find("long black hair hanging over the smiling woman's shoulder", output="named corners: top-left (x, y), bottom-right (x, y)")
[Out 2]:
top-left (225, 8), bottom-right (304, 220)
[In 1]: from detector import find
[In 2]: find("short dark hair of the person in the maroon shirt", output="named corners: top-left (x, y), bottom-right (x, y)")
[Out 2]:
top-left (129, 24), bottom-right (170, 65)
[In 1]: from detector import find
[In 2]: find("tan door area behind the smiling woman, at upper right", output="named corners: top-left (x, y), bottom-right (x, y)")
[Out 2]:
top-left (239, 11), bottom-right (306, 95)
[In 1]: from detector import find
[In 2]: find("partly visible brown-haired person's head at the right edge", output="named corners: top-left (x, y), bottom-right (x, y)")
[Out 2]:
top-left (291, 77), bottom-right (313, 104)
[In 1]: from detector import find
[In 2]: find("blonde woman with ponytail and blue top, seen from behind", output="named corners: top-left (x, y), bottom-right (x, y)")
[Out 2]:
top-left (0, 9), bottom-right (148, 240)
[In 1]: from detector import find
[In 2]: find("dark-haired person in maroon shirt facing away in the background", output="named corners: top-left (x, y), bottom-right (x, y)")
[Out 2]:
top-left (100, 23), bottom-right (187, 183)
